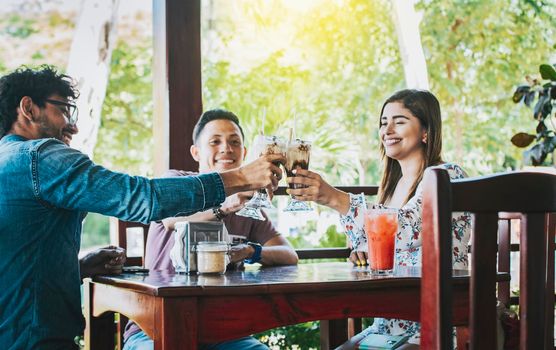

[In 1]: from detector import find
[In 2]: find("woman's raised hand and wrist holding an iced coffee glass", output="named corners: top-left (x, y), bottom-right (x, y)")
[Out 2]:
top-left (286, 169), bottom-right (349, 214)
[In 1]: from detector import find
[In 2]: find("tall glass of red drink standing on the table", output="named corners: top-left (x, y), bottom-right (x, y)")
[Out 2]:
top-left (364, 208), bottom-right (398, 275)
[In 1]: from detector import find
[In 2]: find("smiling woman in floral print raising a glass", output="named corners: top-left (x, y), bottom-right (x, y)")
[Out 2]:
top-left (287, 89), bottom-right (470, 343)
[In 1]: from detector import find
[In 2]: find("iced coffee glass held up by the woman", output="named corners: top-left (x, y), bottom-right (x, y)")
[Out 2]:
top-left (284, 139), bottom-right (313, 211)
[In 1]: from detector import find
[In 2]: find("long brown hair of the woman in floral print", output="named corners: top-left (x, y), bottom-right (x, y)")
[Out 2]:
top-left (378, 89), bottom-right (442, 204)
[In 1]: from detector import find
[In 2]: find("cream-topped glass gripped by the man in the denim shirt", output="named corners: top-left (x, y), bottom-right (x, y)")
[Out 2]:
top-left (236, 135), bottom-right (286, 221)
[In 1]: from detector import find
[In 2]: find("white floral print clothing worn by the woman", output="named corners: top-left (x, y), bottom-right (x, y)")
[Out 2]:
top-left (340, 163), bottom-right (471, 343)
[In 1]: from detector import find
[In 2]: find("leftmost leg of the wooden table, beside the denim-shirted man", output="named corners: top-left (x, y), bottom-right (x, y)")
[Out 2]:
top-left (83, 280), bottom-right (116, 350)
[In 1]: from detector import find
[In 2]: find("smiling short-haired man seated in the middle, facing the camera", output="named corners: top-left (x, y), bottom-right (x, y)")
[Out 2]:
top-left (124, 109), bottom-right (298, 350)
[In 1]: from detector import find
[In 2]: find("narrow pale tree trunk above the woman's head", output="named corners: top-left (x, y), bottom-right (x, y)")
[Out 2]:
top-left (392, 0), bottom-right (429, 89)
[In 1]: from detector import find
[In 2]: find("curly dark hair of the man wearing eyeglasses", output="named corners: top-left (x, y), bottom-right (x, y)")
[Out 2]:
top-left (0, 65), bottom-right (79, 138)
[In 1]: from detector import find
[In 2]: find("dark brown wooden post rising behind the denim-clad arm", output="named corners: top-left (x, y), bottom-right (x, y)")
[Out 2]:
top-left (153, 0), bottom-right (203, 175)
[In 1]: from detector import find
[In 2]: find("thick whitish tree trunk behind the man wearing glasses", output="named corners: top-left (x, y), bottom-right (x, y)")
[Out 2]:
top-left (67, 0), bottom-right (119, 156)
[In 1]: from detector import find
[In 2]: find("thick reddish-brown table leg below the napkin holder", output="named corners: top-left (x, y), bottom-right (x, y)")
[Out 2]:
top-left (153, 298), bottom-right (198, 350)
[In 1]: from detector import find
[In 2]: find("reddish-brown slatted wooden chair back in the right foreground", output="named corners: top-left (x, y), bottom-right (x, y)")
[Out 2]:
top-left (421, 169), bottom-right (556, 349)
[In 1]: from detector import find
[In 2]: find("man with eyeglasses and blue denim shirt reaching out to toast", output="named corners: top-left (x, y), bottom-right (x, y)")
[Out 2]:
top-left (0, 66), bottom-right (284, 349)
